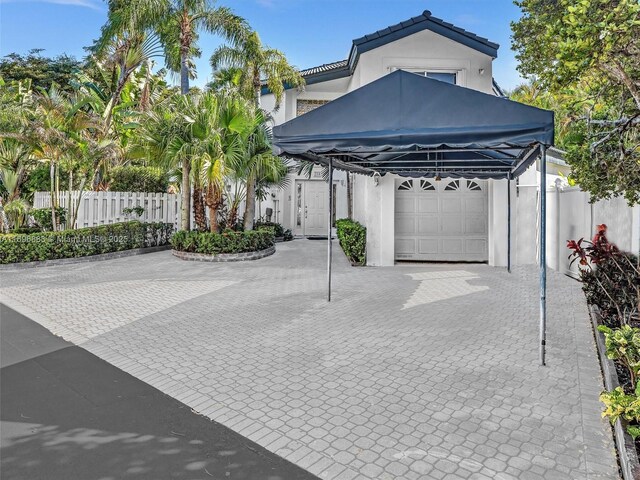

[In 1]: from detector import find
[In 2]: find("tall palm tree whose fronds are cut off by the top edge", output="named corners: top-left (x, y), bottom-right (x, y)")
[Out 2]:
top-left (102, 0), bottom-right (249, 230)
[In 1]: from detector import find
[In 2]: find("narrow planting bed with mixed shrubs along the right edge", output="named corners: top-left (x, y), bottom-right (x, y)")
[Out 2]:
top-left (568, 225), bottom-right (640, 480)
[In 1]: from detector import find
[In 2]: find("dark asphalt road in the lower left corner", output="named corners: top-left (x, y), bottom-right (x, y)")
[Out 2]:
top-left (0, 305), bottom-right (317, 480)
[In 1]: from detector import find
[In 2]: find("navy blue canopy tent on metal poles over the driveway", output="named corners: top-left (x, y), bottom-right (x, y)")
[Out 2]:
top-left (273, 70), bottom-right (554, 364)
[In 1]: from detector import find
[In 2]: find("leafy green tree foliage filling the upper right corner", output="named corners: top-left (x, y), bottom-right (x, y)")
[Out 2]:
top-left (512, 0), bottom-right (640, 204)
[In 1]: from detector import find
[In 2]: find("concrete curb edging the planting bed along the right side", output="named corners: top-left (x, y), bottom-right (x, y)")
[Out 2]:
top-left (589, 306), bottom-right (640, 480)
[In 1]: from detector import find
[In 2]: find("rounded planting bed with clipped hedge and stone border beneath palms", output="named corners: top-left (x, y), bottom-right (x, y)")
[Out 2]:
top-left (171, 227), bottom-right (275, 261)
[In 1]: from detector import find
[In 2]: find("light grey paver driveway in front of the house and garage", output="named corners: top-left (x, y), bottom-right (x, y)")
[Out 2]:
top-left (1, 240), bottom-right (617, 480)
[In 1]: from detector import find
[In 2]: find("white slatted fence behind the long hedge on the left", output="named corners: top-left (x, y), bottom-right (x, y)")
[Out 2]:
top-left (33, 191), bottom-right (180, 228)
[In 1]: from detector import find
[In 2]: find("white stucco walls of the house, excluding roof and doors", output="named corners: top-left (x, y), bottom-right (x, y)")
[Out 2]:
top-left (263, 22), bottom-right (535, 266)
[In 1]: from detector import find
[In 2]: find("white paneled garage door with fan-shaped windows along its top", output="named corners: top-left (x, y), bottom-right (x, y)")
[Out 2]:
top-left (395, 178), bottom-right (488, 262)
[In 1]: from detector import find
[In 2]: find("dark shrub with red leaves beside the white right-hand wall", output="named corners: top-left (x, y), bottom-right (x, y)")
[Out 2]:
top-left (567, 224), bottom-right (640, 326)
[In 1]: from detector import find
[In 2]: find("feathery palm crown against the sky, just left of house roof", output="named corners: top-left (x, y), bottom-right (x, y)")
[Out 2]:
top-left (210, 32), bottom-right (304, 106)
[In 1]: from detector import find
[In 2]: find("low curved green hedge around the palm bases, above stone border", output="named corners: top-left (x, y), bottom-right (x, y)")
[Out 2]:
top-left (171, 228), bottom-right (275, 255)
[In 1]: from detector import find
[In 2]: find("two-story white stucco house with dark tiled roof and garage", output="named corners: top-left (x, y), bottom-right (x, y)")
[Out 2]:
top-left (262, 11), bottom-right (558, 266)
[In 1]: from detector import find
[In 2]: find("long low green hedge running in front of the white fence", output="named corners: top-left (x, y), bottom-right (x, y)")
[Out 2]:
top-left (0, 221), bottom-right (173, 264)
